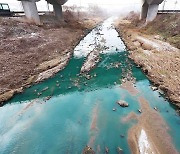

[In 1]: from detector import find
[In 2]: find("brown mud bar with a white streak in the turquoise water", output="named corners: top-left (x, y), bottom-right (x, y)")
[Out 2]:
top-left (122, 80), bottom-right (178, 154)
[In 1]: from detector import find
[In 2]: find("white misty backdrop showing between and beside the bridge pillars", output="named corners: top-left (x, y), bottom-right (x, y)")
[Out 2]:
top-left (0, 0), bottom-right (180, 14)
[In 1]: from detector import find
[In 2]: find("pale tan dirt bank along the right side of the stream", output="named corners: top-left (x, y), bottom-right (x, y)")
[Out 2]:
top-left (116, 13), bottom-right (180, 108)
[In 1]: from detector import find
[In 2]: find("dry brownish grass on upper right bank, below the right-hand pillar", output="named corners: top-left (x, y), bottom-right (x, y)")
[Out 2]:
top-left (125, 12), bottom-right (180, 48)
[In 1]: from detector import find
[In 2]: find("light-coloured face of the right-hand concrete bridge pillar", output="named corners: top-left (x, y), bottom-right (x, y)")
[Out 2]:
top-left (146, 4), bottom-right (159, 22)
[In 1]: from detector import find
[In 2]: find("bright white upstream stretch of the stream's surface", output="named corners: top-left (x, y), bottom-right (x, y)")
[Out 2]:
top-left (74, 18), bottom-right (125, 58)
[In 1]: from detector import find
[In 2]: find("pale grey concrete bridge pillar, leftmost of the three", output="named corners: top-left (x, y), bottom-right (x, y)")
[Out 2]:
top-left (21, 1), bottom-right (40, 24)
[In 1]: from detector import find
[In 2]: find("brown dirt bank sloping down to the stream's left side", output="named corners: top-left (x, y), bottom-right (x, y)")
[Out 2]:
top-left (0, 13), bottom-right (103, 105)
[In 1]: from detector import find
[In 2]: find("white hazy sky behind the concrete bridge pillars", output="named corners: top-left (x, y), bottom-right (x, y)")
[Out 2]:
top-left (0, 0), bottom-right (180, 11)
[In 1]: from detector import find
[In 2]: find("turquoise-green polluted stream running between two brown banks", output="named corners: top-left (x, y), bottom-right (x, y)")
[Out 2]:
top-left (0, 18), bottom-right (180, 154)
